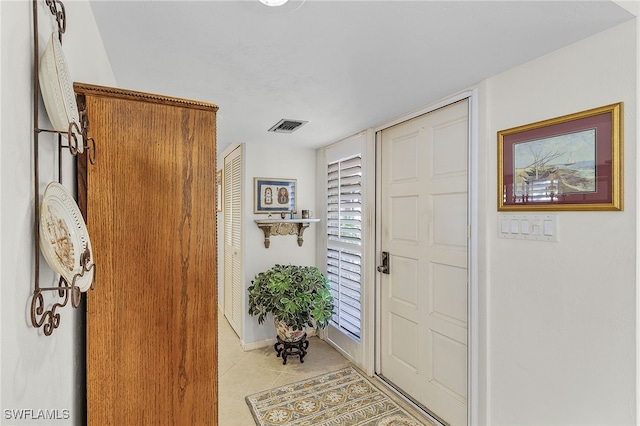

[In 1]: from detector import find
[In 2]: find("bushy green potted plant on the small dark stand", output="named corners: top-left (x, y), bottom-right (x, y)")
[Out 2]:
top-left (248, 265), bottom-right (334, 342)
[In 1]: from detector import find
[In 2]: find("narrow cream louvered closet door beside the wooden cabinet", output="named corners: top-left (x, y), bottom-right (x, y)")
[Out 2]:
top-left (224, 146), bottom-right (244, 337)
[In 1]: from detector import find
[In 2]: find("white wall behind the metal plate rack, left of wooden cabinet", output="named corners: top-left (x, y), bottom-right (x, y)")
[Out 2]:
top-left (0, 0), bottom-right (115, 425)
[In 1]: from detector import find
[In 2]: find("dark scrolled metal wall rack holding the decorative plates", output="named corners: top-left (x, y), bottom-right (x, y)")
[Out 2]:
top-left (31, 0), bottom-right (96, 336)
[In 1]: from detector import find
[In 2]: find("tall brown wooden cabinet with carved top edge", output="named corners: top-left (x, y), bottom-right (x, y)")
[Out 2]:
top-left (74, 83), bottom-right (218, 425)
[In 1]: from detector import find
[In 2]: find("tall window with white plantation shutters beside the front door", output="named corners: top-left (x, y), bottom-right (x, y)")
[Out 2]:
top-left (327, 154), bottom-right (362, 339)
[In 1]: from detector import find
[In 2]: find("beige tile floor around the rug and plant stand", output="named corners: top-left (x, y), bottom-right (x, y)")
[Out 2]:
top-left (218, 315), bottom-right (430, 426)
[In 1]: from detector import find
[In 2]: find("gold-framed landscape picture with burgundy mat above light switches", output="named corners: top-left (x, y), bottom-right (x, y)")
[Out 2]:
top-left (498, 102), bottom-right (623, 211)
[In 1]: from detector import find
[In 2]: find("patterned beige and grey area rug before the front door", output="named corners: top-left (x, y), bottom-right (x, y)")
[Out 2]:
top-left (246, 367), bottom-right (423, 426)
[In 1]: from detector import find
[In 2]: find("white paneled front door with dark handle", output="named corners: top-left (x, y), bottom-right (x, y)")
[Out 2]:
top-left (377, 99), bottom-right (469, 425)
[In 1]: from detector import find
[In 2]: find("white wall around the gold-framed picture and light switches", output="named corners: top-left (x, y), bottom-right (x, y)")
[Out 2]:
top-left (479, 20), bottom-right (638, 425)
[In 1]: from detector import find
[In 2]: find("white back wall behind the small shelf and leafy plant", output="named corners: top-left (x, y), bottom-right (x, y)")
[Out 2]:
top-left (242, 143), bottom-right (322, 345)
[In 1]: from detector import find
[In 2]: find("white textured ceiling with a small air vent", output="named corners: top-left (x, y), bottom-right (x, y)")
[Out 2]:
top-left (90, 0), bottom-right (632, 154)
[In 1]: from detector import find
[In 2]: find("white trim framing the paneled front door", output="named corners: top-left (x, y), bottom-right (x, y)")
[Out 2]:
top-left (368, 87), bottom-right (479, 425)
